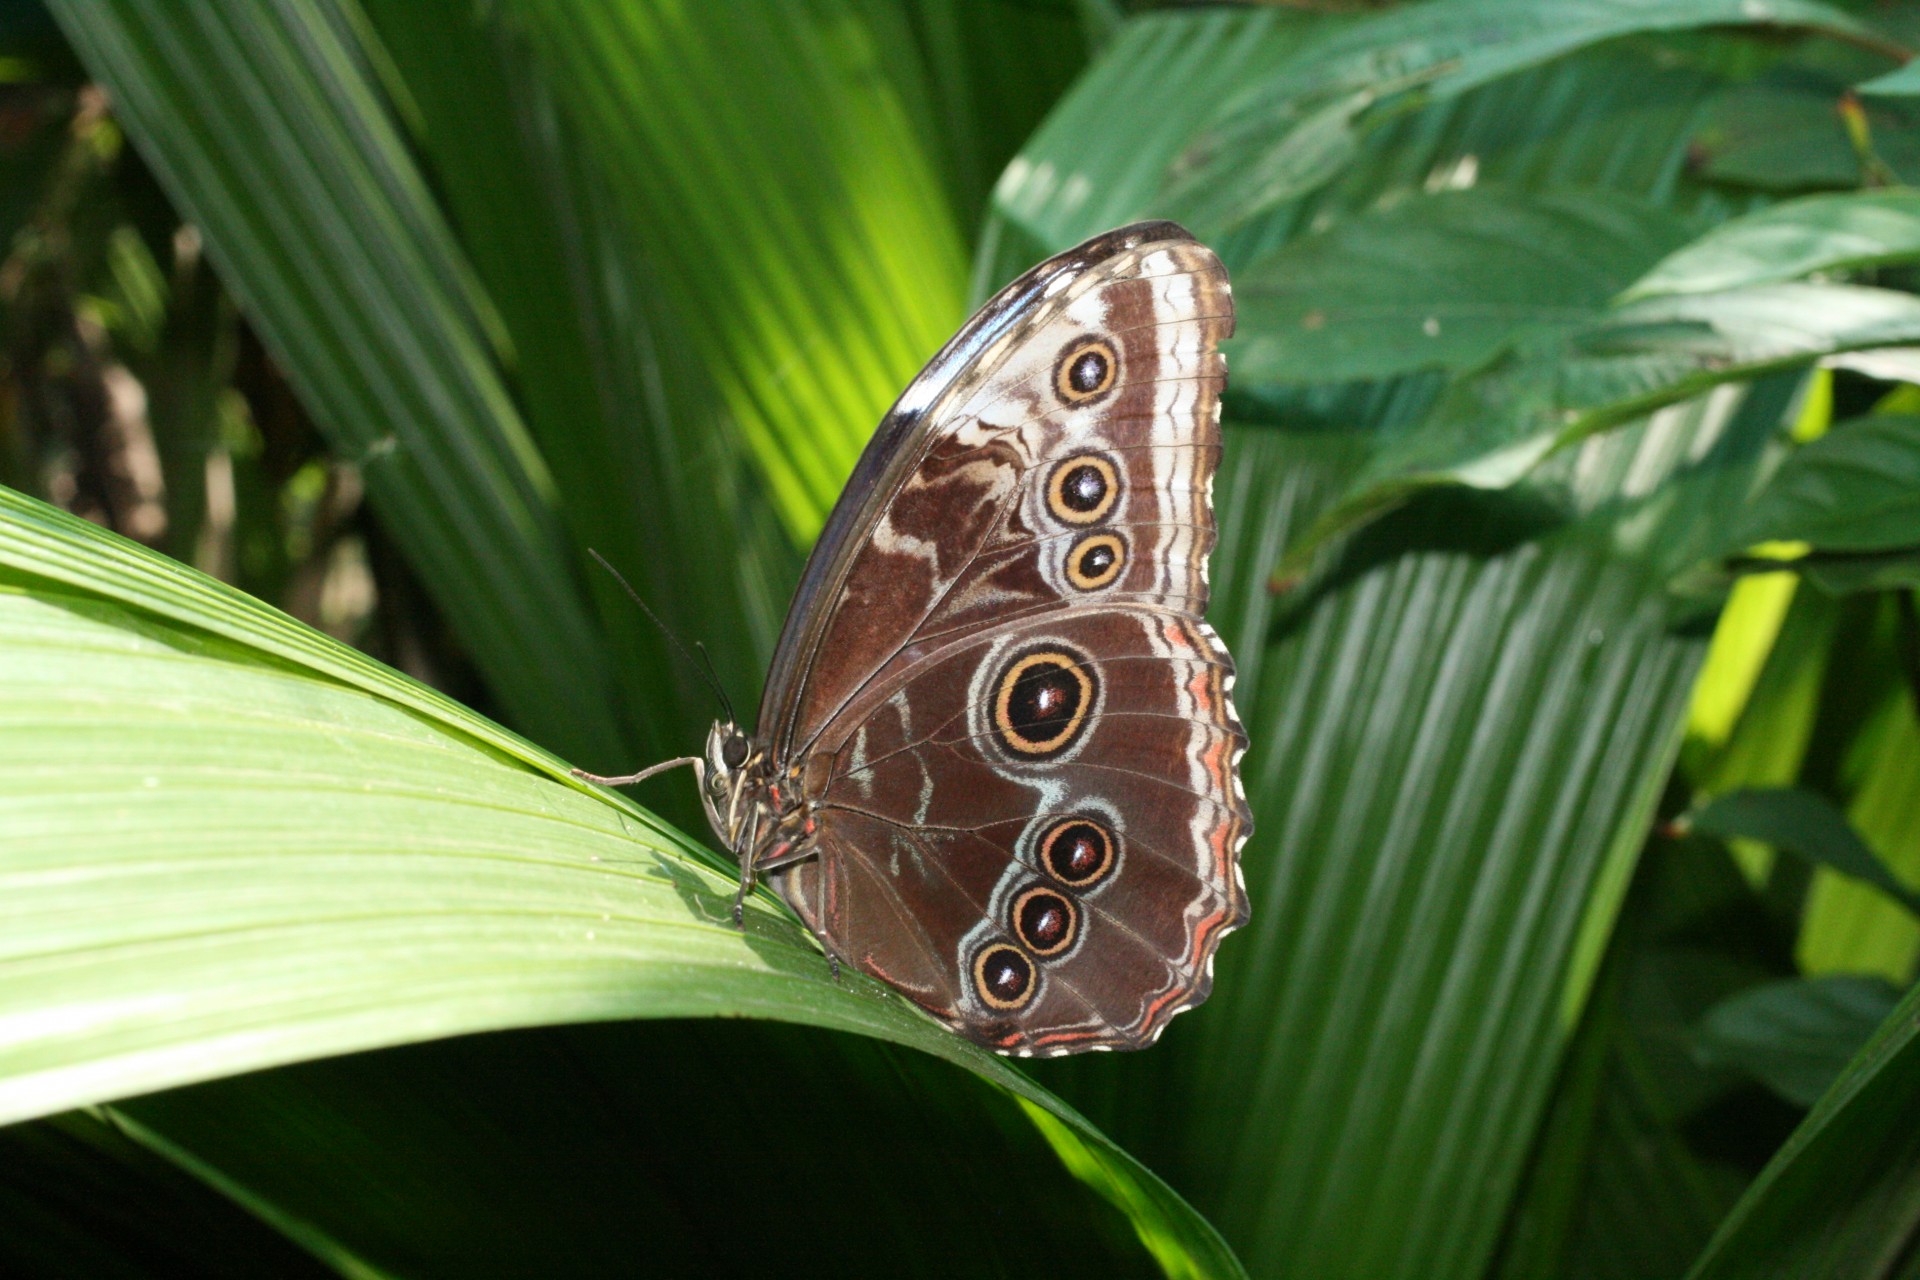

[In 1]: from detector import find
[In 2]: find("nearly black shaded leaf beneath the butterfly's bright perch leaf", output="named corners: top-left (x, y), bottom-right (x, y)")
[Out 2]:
top-left (115, 1019), bottom-right (1205, 1280)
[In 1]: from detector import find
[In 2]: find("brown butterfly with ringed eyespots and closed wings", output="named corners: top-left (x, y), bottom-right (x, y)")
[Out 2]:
top-left (582, 223), bottom-right (1252, 1055)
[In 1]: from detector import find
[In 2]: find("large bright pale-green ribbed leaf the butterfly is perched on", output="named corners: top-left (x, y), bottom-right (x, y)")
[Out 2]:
top-left (0, 491), bottom-right (1236, 1274)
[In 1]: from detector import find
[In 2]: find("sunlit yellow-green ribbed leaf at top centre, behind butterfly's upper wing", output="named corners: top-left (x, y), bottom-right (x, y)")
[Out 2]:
top-left (503, 0), bottom-right (968, 545)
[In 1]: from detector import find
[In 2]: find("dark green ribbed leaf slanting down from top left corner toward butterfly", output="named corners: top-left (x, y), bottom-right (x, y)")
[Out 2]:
top-left (52, 0), bottom-right (626, 771)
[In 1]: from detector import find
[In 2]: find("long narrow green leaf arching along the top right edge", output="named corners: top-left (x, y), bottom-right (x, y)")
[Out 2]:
top-left (1169, 0), bottom-right (1899, 230)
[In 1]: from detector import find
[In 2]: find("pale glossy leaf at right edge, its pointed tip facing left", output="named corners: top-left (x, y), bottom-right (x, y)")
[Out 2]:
top-left (1622, 192), bottom-right (1920, 299)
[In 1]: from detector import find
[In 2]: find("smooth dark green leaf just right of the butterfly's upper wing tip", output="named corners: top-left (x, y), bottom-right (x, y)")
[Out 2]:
top-left (1233, 186), bottom-right (1684, 382)
